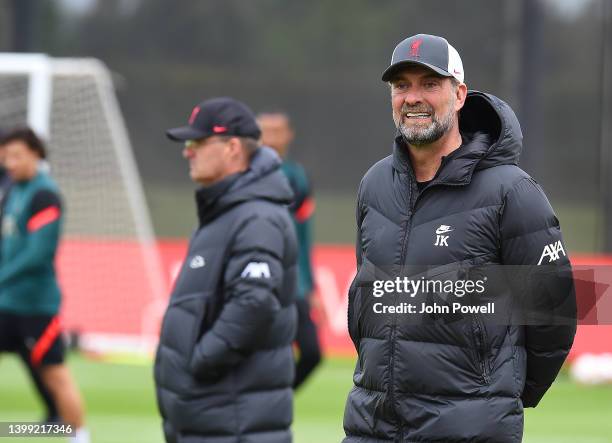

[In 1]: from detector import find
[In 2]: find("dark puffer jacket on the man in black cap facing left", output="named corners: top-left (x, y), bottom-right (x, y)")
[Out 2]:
top-left (155, 148), bottom-right (297, 443)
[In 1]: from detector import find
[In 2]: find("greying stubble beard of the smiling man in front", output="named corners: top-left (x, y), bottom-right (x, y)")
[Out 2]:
top-left (396, 96), bottom-right (455, 147)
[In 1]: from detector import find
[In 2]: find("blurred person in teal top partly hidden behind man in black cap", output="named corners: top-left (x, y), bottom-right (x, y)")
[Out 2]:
top-left (257, 112), bottom-right (321, 389)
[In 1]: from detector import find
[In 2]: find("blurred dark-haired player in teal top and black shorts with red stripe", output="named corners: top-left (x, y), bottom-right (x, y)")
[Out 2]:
top-left (0, 128), bottom-right (90, 443)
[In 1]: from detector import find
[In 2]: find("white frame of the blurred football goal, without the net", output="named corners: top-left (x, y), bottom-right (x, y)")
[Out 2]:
top-left (0, 53), bottom-right (167, 352)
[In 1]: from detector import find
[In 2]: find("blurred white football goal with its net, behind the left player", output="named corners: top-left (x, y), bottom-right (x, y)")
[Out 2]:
top-left (0, 54), bottom-right (167, 356)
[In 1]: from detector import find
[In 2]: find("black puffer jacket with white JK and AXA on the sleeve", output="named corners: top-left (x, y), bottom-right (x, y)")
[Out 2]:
top-left (344, 91), bottom-right (576, 443)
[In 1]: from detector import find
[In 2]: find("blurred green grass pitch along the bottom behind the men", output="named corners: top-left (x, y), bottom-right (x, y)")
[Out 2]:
top-left (0, 354), bottom-right (612, 443)
